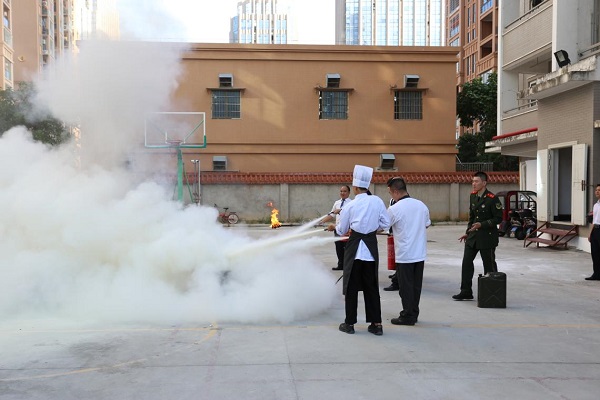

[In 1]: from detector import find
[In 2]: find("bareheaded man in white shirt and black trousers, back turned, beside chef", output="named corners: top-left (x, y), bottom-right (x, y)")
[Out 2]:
top-left (388, 178), bottom-right (431, 325)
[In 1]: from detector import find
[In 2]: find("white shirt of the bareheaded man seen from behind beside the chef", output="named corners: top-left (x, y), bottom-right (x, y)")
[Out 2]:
top-left (388, 197), bottom-right (431, 263)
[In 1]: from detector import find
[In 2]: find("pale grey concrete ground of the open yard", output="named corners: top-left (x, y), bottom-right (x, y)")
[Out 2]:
top-left (0, 225), bottom-right (600, 400)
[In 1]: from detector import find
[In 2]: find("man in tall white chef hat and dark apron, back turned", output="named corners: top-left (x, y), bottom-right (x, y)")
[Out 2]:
top-left (327, 165), bottom-right (390, 336)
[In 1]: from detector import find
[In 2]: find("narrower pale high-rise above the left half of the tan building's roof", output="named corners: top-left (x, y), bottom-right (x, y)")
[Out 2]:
top-left (229, 0), bottom-right (288, 44)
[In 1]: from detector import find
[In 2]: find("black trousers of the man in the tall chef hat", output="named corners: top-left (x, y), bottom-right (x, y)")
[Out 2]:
top-left (344, 260), bottom-right (381, 325)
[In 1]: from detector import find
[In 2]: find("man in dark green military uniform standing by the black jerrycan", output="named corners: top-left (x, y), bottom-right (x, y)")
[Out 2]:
top-left (452, 172), bottom-right (502, 300)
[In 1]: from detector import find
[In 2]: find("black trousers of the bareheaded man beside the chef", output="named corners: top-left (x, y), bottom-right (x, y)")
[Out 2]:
top-left (396, 261), bottom-right (425, 322)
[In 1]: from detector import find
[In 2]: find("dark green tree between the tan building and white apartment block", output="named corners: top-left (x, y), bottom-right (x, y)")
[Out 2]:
top-left (456, 73), bottom-right (519, 171)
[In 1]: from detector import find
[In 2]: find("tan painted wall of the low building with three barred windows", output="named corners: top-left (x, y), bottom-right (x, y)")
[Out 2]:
top-left (163, 44), bottom-right (457, 172)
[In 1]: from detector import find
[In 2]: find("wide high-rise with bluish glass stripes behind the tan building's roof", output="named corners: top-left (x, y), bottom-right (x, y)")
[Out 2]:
top-left (335, 0), bottom-right (444, 46)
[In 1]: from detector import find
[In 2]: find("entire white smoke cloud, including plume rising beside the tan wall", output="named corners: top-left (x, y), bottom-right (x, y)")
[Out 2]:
top-left (0, 25), bottom-right (338, 323)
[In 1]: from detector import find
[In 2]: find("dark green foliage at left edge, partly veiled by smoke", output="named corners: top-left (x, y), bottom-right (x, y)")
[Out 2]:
top-left (0, 83), bottom-right (69, 145)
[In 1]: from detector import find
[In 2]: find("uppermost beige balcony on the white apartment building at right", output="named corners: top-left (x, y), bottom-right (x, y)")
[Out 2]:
top-left (502, 2), bottom-right (552, 74)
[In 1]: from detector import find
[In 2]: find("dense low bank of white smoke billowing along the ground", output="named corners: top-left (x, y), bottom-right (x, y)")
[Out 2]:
top-left (0, 128), bottom-right (337, 322)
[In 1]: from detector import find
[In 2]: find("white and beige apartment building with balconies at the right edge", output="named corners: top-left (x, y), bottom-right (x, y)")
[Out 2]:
top-left (488, 0), bottom-right (600, 249)
